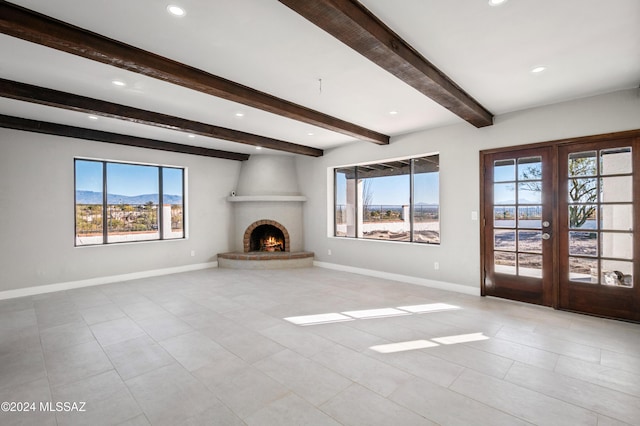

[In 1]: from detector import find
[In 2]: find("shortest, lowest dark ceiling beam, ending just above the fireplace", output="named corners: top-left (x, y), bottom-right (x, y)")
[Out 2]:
top-left (0, 115), bottom-right (249, 161)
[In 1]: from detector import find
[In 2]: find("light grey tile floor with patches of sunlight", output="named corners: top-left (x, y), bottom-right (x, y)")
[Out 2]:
top-left (0, 268), bottom-right (640, 426)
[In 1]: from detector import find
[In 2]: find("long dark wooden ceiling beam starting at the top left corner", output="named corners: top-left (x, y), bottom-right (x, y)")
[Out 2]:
top-left (0, 0), bottom-right (389, 145)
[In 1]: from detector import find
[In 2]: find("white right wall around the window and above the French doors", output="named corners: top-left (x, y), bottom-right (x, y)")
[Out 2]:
top-left (297, 89), bottom-right (640, 288)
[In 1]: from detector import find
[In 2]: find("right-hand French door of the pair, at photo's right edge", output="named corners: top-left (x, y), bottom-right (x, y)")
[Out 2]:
top-left (558, 138), bottom-right (640, 321)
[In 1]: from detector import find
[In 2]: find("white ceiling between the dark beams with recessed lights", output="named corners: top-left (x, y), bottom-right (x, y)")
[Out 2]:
top-left (0, 0), bottom-right (640, 154)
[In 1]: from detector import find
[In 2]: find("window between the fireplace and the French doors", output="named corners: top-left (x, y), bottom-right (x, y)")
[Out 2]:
top-left (334, 154), bottom-right (440, 244)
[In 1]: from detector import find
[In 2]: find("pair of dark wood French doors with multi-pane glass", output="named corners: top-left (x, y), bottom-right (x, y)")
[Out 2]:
top-left (481, 134), bottom-right (640, 321)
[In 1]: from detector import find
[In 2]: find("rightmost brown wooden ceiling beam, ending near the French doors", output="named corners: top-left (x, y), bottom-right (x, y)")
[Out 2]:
top-left (279, 0), bottom-right (493, 127)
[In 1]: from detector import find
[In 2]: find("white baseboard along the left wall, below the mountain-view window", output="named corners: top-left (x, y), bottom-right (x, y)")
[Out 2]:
top-left (0, 262), bottom-right (218, 300)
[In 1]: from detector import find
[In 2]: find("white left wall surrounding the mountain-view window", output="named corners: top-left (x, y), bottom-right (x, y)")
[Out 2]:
top-left (0, 129), bottom-right (241, 291)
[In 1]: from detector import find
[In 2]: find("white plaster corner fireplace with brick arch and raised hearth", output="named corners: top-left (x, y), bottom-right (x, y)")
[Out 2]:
top-left (218, 155), bottom-right (313, 269)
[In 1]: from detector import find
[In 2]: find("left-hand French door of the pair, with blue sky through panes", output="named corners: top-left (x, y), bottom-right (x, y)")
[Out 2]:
top-left (483, 147), bottom-right (555, 306)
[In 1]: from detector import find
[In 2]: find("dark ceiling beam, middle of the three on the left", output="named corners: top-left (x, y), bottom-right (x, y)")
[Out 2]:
top-left (0, 78), bottom-right (323, 157)
